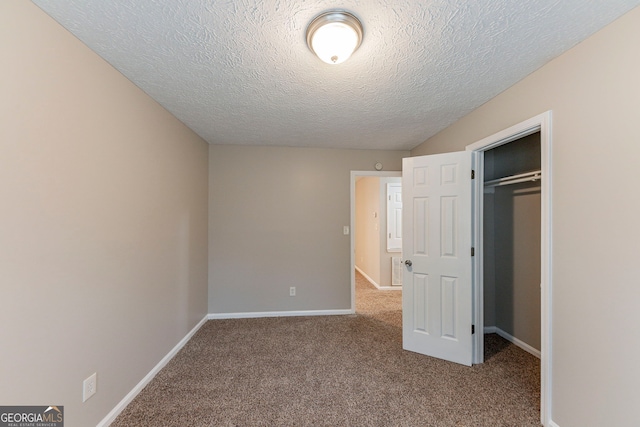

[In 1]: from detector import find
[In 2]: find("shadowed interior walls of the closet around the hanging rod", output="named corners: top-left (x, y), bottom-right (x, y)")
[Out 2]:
top-left (483, 132), bottom-right (544, 350)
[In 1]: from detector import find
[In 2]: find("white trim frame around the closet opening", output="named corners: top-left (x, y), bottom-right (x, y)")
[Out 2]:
top-left (466, 111), bottom-right (552, 426)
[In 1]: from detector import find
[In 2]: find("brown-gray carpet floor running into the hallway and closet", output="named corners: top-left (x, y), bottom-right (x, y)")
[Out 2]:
top-left (112, 274), bottom-right (540, 427)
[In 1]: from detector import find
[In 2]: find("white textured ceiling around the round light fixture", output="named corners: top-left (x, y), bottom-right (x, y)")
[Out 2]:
top-left (34, 0), bottom-right (640, 150)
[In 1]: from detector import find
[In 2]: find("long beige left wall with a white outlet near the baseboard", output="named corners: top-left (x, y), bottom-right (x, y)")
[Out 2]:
top-left (0, 1), bottom-right (208, 427)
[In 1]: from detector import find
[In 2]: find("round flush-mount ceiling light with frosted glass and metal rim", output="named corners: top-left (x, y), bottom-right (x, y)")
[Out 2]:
top-left (307, 10), bottom-right (362, 64)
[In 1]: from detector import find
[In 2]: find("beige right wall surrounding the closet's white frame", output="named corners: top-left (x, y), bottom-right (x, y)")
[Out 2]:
top-left (412, 8), bottom-right (640, 427)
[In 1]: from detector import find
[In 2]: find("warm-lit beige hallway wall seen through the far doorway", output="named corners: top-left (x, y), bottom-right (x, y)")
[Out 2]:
top-left (355, 177), bottom-right (386, 286)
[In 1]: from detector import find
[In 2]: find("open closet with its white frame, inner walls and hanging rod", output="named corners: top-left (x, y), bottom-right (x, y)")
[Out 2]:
top-left (466, 111), bottom-right (553, 425)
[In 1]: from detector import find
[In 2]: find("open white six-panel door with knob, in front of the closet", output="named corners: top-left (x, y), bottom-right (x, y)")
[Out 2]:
top-left (402, 151), bottom-right (473, 366)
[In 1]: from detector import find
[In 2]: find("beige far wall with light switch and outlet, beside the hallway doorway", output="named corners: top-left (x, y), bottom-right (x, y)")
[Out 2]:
top-left (209, 145), bottom-right (409, 313)
